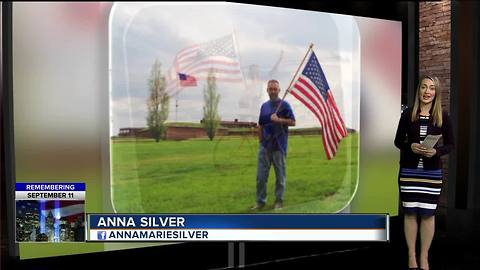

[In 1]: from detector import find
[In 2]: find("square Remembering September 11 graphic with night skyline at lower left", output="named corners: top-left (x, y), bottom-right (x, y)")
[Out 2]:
top-left (15, 183), bottom-right (85, 242)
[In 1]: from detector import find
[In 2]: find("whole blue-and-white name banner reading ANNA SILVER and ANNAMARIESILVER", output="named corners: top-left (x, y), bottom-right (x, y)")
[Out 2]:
top-left (87, 214), bottom-right (389, 242)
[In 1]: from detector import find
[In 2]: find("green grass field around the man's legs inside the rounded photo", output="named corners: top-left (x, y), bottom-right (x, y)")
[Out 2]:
top-left (111, 134), bottom-right (359, 213)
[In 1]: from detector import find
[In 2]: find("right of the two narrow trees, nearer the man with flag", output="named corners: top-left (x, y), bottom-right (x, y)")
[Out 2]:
top-left (202, 69), bottom-right (220, 140)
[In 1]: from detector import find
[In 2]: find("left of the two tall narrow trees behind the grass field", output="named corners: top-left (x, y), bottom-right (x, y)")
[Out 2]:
top-left (147, 59), bottom-right (170, 142)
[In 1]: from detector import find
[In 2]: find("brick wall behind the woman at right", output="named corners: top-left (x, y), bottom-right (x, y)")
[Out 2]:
top-left (418, 0), bottom-right (451, 211)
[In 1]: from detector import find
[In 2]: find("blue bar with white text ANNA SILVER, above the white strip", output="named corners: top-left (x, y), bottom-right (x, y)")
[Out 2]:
top-left (88, 214), bottom-right (388, 229)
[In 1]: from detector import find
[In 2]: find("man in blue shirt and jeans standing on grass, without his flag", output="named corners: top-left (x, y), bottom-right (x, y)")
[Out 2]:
top-left (252, 80), bottom-right (295, 210)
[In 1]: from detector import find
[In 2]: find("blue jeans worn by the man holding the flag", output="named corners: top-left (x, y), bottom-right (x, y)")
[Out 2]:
top-left (257, 145), bottom-right (287, 204)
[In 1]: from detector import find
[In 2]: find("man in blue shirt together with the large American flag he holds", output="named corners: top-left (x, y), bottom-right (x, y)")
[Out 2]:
top-left (252, 44), bottom-right (347, 210)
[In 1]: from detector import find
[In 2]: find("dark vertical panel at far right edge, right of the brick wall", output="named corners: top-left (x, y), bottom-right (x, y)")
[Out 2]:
top-left (448, 1), bottom-right (480, 245)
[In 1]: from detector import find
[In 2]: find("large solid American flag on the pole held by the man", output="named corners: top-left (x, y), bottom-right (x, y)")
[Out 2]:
top-left (289, 50), bottom-right (347, 159)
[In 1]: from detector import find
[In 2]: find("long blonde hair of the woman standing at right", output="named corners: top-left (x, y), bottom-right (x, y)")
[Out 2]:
top-left (412, 75), bottom-right (442, 127)
